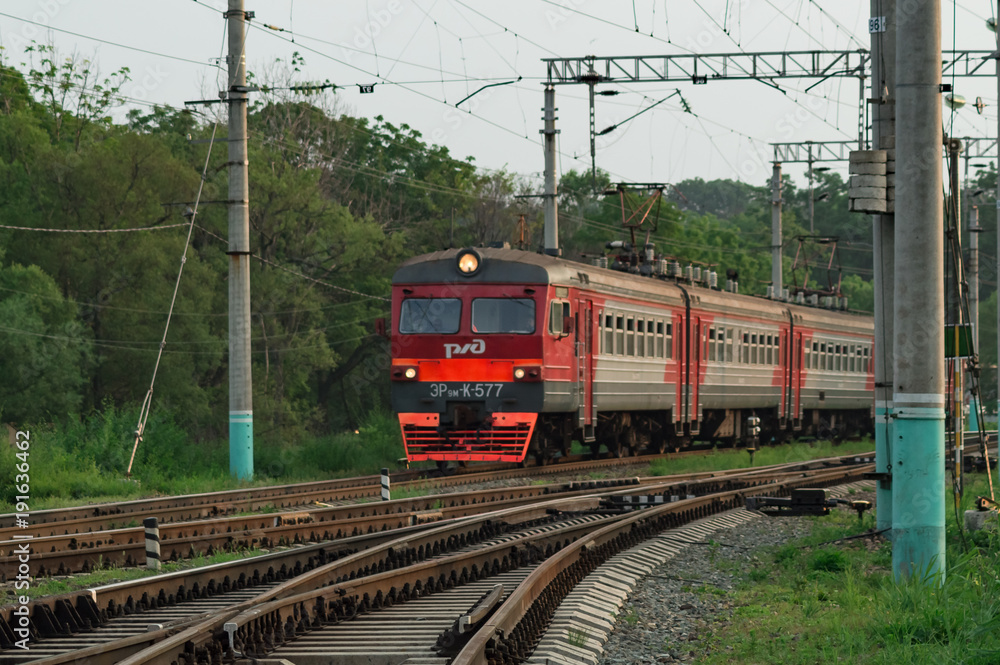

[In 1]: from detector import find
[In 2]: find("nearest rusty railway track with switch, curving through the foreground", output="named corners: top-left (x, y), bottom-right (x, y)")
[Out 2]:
top-left (0, 460), bottom-right (869, 665)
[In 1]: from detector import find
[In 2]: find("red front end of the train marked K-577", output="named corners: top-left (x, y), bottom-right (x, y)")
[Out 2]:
top-left (391, 248), bottom-right (564, 462)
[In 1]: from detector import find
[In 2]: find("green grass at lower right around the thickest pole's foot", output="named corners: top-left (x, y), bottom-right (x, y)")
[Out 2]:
top-left (698, 474), bottom-right (1000, 665)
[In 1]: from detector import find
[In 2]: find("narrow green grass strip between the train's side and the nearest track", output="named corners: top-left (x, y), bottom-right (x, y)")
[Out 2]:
top-left (649, 438), bottom-right (875, 476)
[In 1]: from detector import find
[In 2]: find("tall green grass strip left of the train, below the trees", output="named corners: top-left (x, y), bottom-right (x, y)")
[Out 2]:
top-left (0, 407), bottom-right (403, 513)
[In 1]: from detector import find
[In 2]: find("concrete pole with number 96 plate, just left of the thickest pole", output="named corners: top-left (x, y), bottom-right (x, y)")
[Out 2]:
top-left (872, 0), bottom-right (896, 539)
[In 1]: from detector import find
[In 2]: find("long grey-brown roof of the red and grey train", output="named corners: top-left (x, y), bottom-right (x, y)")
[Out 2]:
top-left (392, 247), bottom-right (872, 330)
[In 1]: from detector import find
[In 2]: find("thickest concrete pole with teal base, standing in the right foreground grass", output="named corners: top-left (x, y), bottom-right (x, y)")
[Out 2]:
top-left (892, 0), bottom-right (945, 582)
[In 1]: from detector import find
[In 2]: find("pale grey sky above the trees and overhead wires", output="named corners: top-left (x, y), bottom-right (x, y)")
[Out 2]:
top-left (0, 0), bottom-right (997, 185)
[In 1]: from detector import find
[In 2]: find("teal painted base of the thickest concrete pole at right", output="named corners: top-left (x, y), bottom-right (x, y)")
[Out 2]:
top-left (892, 407), bottom-right (945, 583)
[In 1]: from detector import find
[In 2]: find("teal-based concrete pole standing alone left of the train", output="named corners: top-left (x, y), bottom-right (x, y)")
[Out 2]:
top-left (225, 0), bottom-right (253, 480)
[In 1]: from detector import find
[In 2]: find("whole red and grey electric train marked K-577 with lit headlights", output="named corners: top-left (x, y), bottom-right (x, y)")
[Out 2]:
top-left (390, 244), bottom-right (874, 463)
